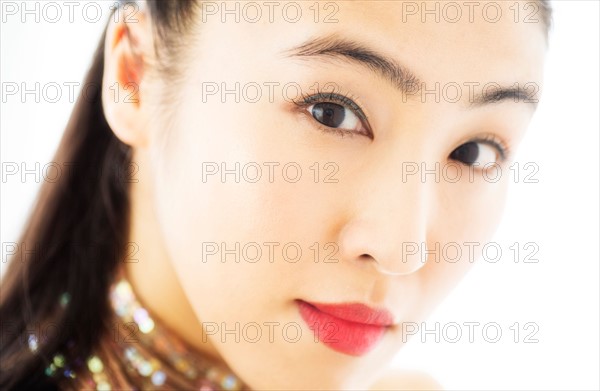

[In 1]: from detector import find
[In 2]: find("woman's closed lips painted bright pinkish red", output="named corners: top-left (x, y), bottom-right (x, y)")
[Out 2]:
top-left (296, 300), bottom-right (394, 356)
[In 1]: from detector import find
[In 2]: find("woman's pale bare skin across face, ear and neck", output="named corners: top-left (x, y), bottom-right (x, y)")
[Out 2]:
top-left (103, 1), bottom-right (545, 389)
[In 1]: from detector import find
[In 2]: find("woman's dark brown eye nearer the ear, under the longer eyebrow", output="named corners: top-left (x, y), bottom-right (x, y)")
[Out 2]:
top-left (295, 93), bottom-right (373, 139)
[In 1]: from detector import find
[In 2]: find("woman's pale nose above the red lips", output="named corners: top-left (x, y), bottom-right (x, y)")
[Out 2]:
top-left (338, 176), bottom-right (435, 276)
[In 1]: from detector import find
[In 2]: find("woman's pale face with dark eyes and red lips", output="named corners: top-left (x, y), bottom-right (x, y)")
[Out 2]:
top-left (138, 1), bottom-right (546, 389)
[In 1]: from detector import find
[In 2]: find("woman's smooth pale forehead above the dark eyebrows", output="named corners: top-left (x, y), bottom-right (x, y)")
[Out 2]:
top-left (198, 0), bottom-right (546, 84)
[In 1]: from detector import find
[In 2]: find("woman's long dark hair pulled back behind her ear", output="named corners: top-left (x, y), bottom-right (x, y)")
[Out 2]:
top-left (0, 0), bottom-right (551, 389)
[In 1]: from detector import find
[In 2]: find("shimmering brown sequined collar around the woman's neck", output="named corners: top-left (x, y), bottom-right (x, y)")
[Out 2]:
top-left (41, 275), bottom-right (249, 391)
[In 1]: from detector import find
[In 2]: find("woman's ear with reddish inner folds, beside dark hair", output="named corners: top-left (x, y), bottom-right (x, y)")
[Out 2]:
top-left (102, 4), bottom-right (153, 147)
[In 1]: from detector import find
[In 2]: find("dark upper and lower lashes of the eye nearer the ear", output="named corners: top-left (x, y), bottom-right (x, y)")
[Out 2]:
top-left (293, 87), bottom-right (373, 139)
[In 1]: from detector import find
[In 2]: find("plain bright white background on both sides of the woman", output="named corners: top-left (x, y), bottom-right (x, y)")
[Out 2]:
top-left (0, 1), bottom-right (600, 390)
